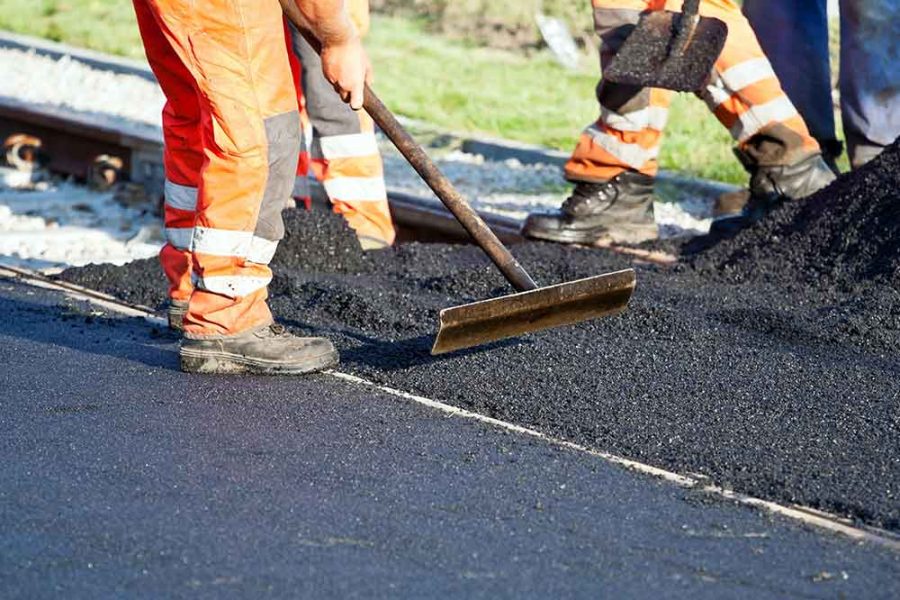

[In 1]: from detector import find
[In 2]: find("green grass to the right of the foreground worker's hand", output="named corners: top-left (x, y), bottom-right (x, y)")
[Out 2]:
top-left (368, 18), bottom-right (746, 181)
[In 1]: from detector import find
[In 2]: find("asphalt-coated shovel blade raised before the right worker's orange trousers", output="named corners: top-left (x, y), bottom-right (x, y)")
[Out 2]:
top-left (603, 0), bottom-right (728, 92)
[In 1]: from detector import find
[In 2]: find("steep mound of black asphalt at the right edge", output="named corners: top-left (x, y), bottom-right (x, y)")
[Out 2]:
top-left (693, 140), bottom-right (900, 291)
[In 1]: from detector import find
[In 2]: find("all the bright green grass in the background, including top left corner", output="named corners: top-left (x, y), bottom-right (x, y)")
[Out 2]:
top-left (0, 0), bottom-right (746, 182)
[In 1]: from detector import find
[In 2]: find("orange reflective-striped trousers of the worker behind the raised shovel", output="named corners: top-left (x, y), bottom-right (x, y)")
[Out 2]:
top-left (566, 0), bottom-right (819, 181)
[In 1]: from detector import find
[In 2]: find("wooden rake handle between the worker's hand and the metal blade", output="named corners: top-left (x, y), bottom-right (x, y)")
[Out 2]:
top-left (363, 85), bottom-right (537, 292)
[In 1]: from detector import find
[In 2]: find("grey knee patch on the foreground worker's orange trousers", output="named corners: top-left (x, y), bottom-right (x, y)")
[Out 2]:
top-left (254, 110), bottom-right (300, 241)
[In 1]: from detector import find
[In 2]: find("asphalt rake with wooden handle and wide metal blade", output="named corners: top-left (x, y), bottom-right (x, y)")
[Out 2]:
top-left (282, 5), bottom-right (635, 354)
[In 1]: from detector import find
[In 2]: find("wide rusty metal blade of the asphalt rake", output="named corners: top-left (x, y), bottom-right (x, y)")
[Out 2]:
top-left (431, 269), bottom-right (635, 355)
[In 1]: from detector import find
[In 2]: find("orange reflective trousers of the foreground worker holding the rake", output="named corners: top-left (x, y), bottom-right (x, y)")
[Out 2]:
top-left (134, 0), bottom-right (300, 337)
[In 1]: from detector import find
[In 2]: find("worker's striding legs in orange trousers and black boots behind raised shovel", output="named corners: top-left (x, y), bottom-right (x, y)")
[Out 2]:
top-left (524, 0), bottom-right (834, 244)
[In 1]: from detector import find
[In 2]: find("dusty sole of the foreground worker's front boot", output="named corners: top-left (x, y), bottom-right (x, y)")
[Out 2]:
top-left (180, 348), bottom-right (340, 375)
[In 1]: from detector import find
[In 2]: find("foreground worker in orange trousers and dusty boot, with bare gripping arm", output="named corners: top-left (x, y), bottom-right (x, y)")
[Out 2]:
top-left (134, 0), bottom-right (370, 374)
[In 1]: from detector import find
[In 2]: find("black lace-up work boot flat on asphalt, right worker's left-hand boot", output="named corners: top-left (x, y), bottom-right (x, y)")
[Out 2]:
top-left (522, 171), bottom-right (659, 244)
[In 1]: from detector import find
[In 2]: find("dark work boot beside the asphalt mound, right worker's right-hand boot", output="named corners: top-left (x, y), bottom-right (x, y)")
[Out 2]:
top-left (710, 149), bottom-right (836, 235)
